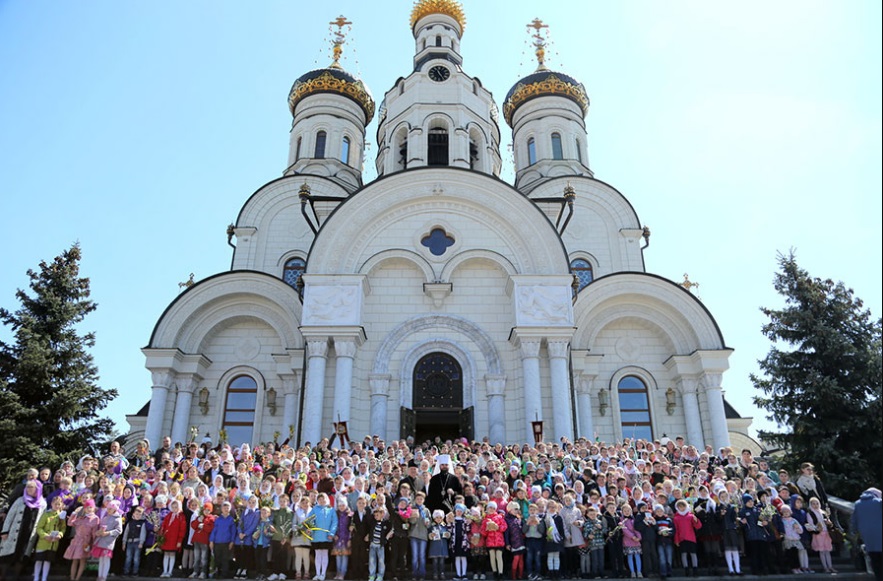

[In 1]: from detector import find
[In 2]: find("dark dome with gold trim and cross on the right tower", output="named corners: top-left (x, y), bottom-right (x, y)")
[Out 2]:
top-left (503, 18), bottom-right (589, 127)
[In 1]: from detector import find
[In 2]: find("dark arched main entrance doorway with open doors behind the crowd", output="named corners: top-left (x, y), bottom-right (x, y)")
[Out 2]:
top-left (401, 351), bottom-right (473, 442)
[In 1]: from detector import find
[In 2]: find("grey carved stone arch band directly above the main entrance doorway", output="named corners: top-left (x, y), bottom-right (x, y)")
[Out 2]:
top-left (371, 315), bottom-right (504, 375)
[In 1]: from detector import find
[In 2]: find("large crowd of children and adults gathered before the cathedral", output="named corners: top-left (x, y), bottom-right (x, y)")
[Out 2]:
top-left (0, 437), bottom-right (856, 581)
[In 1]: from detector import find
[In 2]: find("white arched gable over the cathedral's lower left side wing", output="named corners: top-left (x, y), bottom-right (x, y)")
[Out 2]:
top-left (150, 271), bottom-right (302, 353)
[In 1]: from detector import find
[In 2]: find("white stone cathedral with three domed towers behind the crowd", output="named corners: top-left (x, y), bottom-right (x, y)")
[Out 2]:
top-left (127, 0), bottom-right (747, 449)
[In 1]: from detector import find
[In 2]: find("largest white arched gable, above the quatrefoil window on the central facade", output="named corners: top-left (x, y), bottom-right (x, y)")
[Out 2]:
top-left (307, 168), bottom-right (569, 274)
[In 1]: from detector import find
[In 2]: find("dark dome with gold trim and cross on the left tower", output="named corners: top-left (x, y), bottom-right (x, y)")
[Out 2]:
top-left (288, 16), bottom-right (374, 125)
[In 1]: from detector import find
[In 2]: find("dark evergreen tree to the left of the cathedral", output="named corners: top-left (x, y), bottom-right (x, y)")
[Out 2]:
top-left (0, 244), bottom-right (117, 490)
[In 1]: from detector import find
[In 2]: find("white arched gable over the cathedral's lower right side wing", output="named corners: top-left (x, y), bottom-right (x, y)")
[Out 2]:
top-left (574, 273), bottom-right (725, 354)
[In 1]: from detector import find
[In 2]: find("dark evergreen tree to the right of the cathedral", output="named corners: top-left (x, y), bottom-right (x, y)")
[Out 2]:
top-left (751, 251), bottom-right (883, 499)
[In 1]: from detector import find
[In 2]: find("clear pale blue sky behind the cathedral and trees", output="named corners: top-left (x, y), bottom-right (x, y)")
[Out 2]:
top-left (0, 0), bottom-right (883, 440)
